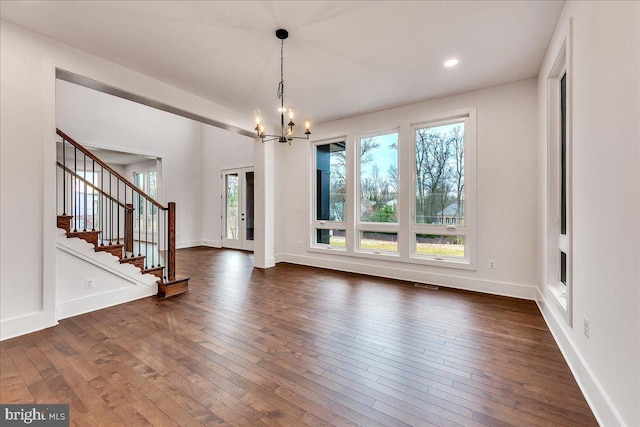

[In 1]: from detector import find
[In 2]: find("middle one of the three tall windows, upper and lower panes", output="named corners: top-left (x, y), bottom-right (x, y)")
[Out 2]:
top-left (358, 132), bottom-right (399, 254)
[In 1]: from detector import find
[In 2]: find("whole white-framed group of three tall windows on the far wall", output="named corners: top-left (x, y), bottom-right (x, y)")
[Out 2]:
top-left (309, 108), bottom-right (476, 270)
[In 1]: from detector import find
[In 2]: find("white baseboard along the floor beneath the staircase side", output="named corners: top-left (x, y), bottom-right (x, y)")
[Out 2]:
top-left (56, 284), bottom-right (158, 319)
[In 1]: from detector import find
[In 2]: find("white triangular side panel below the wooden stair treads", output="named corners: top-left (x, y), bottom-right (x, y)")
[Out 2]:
top-left (56, 229), bottom-right (158, 319)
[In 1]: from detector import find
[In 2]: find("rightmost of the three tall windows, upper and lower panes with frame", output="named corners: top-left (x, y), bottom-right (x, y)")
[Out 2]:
top-left (411, 115), bottom-right (475, 264)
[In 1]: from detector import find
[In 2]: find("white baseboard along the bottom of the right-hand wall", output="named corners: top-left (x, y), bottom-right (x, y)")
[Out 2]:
top-left (536, 289), bottom-right (625, 427)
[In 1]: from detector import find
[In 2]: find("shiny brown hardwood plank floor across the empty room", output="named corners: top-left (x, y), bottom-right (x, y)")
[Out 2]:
top-left (0, 248), bottom-right (597, 427)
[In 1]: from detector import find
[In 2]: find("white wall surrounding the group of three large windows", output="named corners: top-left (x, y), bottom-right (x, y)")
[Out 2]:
top-left (275, 79), bottom-right (538, 299)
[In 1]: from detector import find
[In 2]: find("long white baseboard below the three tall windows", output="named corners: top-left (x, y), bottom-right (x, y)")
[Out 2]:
top-left (275, 254), bottom-right (537, 300)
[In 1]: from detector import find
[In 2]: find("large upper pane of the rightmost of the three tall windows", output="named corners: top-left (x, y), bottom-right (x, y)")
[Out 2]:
top-left (415, 122), bottom-right (465, 225)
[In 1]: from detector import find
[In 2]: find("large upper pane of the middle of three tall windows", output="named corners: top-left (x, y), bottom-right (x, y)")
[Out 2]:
top-left (360, 133), bottom-right (398, 222)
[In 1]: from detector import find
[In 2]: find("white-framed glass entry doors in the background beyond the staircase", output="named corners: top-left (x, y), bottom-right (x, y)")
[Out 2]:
top-left (222, 168), bottom-right (254, 251)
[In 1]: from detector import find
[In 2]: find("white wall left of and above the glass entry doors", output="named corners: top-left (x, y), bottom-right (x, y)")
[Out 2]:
top-left (202, 125), bottom-right (254, 247)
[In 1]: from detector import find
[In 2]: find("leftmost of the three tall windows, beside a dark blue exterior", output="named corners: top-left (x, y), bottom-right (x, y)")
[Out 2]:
top-left (313, 141), bottom-right (347, 249)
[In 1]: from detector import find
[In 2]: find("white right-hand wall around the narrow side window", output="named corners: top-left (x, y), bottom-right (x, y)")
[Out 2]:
top-left (538, 1), bottom-right (640, 426)
